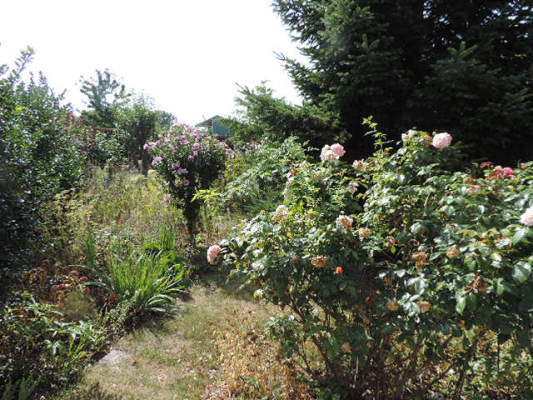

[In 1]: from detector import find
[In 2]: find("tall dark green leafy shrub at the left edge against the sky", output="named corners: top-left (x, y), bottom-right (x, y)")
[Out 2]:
top-left (0, 49), bottom-right (84, 283)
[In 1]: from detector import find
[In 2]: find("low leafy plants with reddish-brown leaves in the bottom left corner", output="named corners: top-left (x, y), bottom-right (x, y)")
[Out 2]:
top-left (0, 293), bottom-right (105, 398)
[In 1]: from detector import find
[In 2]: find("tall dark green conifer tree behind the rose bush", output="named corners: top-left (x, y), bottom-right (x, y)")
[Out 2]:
top-left (272, 0), bottom-right (533, 162)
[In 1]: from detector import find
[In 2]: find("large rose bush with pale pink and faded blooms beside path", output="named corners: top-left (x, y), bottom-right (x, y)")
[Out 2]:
top-left (221, 125), bottom-right (533, 398)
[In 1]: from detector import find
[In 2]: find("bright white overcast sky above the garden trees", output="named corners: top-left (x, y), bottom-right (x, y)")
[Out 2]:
top-left (0, 0), bottom-right (300, 124)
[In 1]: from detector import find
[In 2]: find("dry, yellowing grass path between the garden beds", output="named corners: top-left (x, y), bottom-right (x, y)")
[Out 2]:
top-left (68, 285), bottom-right (274, 400)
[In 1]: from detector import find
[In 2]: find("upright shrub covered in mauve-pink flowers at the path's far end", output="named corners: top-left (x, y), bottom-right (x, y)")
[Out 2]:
top-left (145, 121), bottom-right (231, 237)
